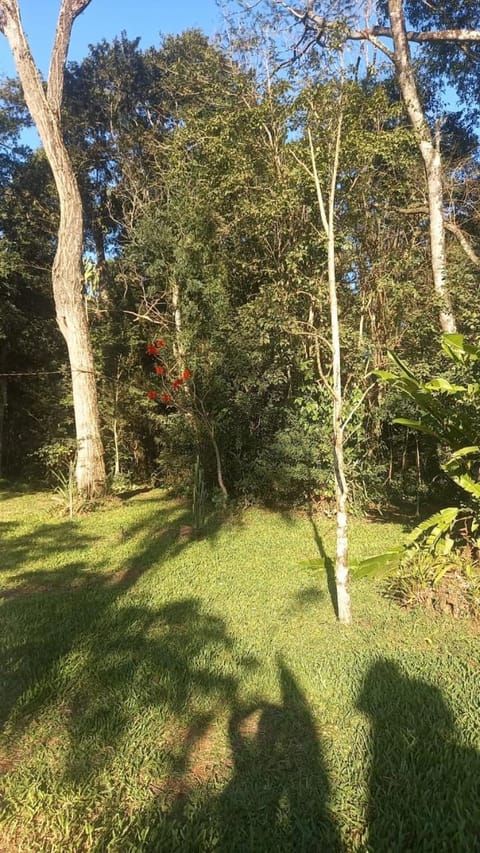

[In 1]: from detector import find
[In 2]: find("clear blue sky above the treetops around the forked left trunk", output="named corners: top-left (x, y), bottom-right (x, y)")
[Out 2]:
top-left (0, 0), bottom-right (221, 77)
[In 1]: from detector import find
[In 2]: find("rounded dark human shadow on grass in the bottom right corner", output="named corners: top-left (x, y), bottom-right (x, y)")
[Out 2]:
top-left (358, 660), bottom-right (480, 853)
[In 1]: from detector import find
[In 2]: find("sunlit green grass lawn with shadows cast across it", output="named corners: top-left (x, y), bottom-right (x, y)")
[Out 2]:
top-left (0, 491), bottom-right (480, 853)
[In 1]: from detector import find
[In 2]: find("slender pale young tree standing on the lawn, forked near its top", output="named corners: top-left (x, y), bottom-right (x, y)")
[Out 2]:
top-left (308, 120), bottom-right (352, 625)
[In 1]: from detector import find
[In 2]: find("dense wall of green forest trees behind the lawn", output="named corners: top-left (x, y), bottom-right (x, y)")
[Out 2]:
top-left (0, 0), bottom-right (480, 532)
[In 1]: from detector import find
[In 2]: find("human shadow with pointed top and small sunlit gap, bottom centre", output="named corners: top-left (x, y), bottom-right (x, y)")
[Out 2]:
top-left (218, 660), bottom-right (343, 853)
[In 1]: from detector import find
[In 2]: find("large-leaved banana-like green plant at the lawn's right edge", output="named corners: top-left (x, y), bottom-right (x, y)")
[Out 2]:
top-left (355, 334), bottom-right (480, 578)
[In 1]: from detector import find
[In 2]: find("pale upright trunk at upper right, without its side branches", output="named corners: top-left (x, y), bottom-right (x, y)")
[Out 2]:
top-left (388, 0), bottom-right (456, 333)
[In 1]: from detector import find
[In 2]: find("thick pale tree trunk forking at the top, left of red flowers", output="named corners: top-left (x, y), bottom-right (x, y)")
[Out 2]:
top-left (0, 0), bottom-right (106, 497)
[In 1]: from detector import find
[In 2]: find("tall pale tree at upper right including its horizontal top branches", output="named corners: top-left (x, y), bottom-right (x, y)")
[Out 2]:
top-left (275, 0), bottom-right (480, 333)
